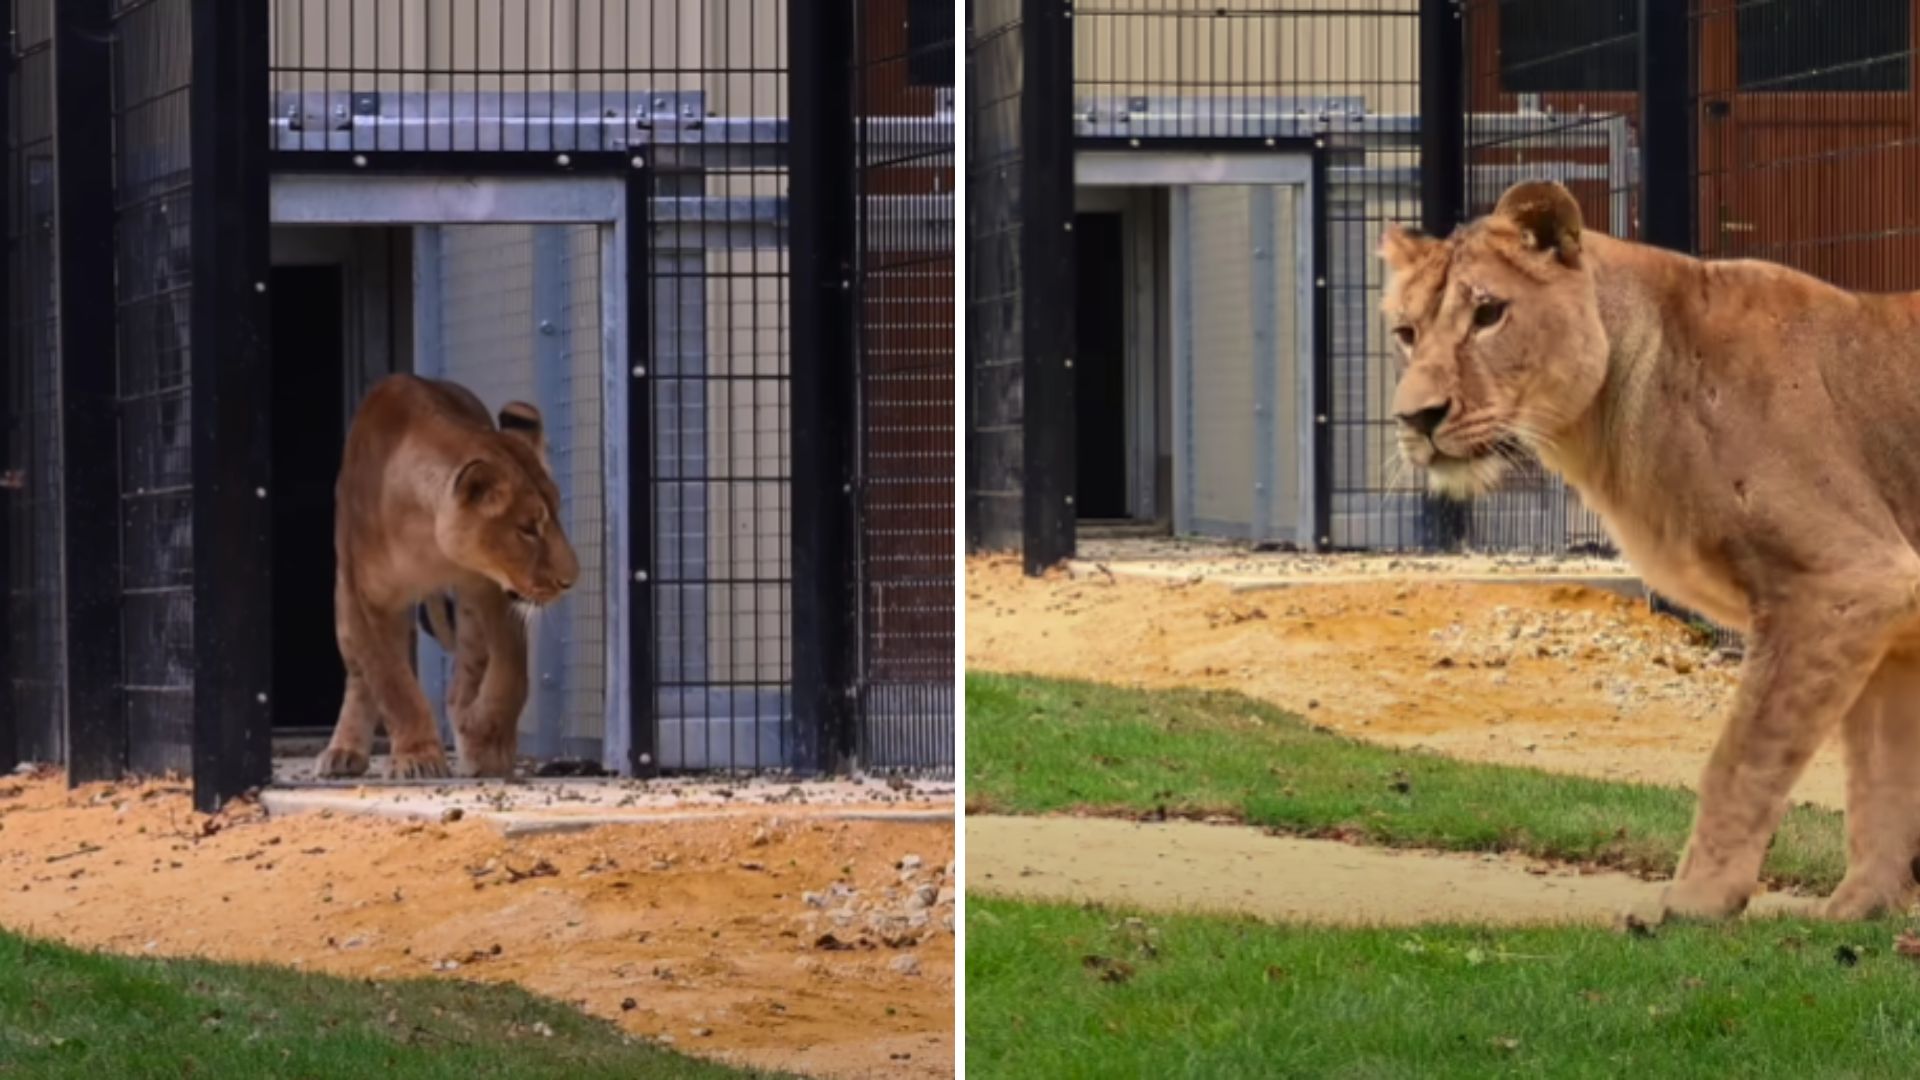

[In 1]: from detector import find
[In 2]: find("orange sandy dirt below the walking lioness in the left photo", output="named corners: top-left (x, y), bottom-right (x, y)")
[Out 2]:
top-left (0, 773), bottom-right (954, 1078)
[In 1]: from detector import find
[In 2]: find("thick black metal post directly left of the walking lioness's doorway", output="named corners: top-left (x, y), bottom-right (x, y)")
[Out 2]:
top-left (187, 0), bottom-right (274, 811)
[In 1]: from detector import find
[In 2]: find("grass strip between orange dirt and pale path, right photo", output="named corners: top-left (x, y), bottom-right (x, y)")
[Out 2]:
top-left (966, 675), bottom-right (1845, 892)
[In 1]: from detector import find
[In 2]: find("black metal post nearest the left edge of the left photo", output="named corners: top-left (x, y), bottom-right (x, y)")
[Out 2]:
top-left (54, 0), bottom-right (127, 784)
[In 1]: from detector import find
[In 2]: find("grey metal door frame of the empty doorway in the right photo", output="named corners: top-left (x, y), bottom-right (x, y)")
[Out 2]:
top-left (1073, 138), bottom-right (1332, 550)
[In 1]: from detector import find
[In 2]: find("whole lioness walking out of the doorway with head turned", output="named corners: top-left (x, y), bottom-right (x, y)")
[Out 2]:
top-left (317, 375), bottom-right (580, 778)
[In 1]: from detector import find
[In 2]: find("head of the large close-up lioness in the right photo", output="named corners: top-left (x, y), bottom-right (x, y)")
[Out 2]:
top-left (1380, 183), bottom-right (1607, 498)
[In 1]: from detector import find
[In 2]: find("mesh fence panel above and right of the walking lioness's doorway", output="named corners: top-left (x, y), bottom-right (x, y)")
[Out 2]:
top-left (269, 0), bottom-right (814, 771)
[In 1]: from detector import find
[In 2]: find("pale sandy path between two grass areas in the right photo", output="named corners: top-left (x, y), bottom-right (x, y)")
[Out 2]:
top-left (966, 815), bottom-right (1814, 926)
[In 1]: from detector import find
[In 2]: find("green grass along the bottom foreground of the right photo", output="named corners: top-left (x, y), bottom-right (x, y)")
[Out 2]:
top-left (966, 891), bottom-right (1920, 1080)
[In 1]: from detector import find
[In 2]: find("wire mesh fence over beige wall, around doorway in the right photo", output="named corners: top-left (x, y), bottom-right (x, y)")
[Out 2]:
top-left (1073, 0), bottom-right (1427, 548)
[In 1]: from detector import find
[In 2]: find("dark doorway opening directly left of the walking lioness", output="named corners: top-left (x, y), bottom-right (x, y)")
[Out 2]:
top-left (271, 265), bottom-right (346, 728)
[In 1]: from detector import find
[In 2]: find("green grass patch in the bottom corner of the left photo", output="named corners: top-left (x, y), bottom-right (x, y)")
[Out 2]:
top-left (0, 932), bottom-right (787, 1080)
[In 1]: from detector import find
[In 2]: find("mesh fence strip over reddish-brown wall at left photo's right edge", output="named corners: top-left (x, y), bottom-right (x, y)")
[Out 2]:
top-left (854, 0), bottom-right (954, 769)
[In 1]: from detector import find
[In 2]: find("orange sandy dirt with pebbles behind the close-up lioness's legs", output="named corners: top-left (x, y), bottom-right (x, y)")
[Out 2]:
top-left (966, 542), bottom-right (1845, 807)
